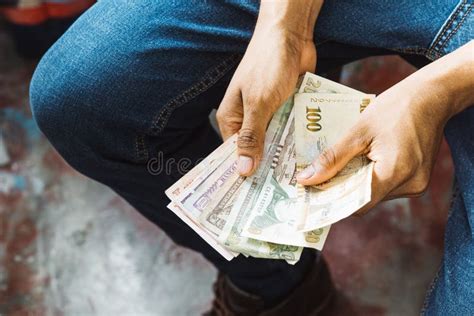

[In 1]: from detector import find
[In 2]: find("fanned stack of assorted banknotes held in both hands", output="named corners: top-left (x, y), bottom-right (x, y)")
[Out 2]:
top-left (166, 73), bottom-right (375, 264)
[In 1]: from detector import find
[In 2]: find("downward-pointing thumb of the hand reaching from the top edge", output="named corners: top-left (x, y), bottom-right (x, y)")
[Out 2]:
top-left (237, 105), bottom-right (270, 176)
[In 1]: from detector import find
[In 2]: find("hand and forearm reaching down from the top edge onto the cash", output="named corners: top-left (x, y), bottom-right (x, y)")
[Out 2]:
top-left (217, 0), bottom-right (322, 176)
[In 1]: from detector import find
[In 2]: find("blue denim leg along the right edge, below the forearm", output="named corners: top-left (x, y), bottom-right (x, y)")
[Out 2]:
top-left (424, 107), bottom-right (474, 316)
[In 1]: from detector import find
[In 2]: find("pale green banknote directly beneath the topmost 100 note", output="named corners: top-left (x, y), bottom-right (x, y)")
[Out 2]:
top-left (239, 110), bottom-right (329, 250)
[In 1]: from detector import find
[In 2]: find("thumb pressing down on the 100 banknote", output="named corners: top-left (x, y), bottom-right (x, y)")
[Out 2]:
top-left (296, 127), bottom-right (371, 185)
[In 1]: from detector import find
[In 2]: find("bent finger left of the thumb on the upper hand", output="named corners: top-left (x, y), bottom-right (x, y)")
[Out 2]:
top-left (216, 82), bottom-right (244, 141)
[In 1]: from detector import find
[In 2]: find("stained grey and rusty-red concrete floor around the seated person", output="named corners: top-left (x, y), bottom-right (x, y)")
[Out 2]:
top-left (0, 25), bottom-right (452, 316)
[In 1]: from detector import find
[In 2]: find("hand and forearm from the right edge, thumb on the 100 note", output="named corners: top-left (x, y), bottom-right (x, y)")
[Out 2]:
top-left (297, 42), bottom-right (474, 215)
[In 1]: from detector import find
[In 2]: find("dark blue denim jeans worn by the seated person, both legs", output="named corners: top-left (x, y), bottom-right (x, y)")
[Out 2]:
top-left (31, 0), bottom-right (474, 315)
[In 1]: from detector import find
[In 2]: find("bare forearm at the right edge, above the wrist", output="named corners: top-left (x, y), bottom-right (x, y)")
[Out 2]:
top-left (415, 40), bottom-right (474, 118)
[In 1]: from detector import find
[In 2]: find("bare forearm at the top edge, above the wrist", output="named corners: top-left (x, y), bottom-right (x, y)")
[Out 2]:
top-left (256, 0), bottom-right (323, 41)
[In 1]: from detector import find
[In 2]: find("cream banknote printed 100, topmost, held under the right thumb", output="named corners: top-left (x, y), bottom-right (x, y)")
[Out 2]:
top-left (295, 93), bottom-right (374, 231)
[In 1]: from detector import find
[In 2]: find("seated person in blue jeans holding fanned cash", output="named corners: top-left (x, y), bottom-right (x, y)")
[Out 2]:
top-left (30, 0), bottom-right (474, 315)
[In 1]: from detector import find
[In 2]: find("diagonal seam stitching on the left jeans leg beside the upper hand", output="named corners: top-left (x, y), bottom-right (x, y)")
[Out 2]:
top-left (149, 54), bottom-right (241, 135)
